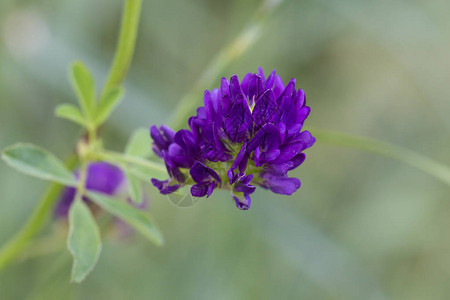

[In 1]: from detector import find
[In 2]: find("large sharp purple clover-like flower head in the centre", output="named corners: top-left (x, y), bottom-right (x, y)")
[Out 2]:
top-left (150, 68), bottom-right (316, 210)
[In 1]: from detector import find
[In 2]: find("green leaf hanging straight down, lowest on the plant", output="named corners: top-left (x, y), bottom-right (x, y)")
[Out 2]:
top-left (67, 198), bottom-right (102, 283)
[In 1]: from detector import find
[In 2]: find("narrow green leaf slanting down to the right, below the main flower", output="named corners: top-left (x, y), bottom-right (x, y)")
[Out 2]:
top-left (87, 192), bottom-right (164, 246)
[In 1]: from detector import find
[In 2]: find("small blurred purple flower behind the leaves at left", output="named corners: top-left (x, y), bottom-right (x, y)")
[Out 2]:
top-left (55, 162), bottom-right (126, 217)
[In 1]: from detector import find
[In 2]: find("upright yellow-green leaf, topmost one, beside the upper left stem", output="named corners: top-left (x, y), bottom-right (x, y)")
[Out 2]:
top-left (70, 61), bottom-right (95, 120)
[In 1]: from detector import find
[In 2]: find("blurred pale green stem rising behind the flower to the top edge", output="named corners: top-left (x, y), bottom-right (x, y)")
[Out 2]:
top-left (170, 0), bottom-right (284, 129)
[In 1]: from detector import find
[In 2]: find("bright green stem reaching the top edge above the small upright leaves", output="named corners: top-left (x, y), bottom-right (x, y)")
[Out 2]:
top-left (102, 0), bottom-right (142, 95)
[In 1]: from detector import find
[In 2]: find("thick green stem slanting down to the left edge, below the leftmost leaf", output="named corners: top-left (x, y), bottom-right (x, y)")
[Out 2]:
top-left (0, 155), bottom-right (77, 270)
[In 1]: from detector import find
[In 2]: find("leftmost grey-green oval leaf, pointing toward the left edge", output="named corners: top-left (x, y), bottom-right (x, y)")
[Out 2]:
top-left (2, 143), bottom-right (76, 186)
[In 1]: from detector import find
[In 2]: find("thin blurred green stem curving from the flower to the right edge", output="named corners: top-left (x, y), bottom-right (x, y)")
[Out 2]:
top-left (310, 129), bottom-right (450, 186)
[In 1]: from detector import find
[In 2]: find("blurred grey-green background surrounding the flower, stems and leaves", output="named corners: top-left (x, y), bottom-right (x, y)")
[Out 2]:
top-left (0, 0), bottom-right (450, 300)
